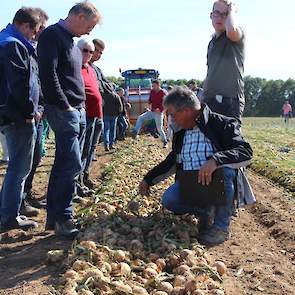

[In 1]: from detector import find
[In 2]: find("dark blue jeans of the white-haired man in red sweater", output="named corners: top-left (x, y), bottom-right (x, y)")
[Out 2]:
top-left (82, 117), bottom-right (103, 173)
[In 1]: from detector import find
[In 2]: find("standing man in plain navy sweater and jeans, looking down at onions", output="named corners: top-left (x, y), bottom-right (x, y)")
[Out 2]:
top-left (37, 1), bottom-right (101, 237)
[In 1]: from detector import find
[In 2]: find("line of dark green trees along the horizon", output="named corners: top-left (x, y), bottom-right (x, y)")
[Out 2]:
top-left (108, 76), bottom-right (295, 117)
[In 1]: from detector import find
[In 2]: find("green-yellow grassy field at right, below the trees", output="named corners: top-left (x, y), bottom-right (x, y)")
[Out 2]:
top-left (242, 118), bottom-right (295, 192)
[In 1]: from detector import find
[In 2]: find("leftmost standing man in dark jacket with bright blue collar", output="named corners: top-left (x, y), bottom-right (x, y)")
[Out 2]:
top-left (0, 7), bottom-right (40, 231)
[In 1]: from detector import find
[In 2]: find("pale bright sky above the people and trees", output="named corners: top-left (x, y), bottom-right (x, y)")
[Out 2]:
top-left (0, 0), bottom-right (295, 80)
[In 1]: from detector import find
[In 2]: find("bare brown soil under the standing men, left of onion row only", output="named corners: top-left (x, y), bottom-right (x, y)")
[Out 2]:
top-left (0, 141), bottom-right (111, 295)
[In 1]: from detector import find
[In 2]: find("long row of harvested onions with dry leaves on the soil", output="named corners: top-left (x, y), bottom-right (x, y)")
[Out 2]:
top-left (60, 137), bottom-right (227, 295)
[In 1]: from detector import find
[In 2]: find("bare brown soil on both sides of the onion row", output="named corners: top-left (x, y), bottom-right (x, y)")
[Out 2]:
top-left (0, 142), bottom-right (295, 295)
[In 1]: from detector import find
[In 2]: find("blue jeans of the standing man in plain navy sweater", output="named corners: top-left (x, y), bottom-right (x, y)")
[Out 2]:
top-left (45, 105), bottom-right (86, 224)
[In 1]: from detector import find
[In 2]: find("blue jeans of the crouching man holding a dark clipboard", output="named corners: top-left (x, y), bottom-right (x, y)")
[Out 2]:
top-left (162, 168), bottom-right (237, 231)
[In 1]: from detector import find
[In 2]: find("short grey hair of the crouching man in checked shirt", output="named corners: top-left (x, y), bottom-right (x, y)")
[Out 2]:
top-left (164, 86), bottom-right (201, 111)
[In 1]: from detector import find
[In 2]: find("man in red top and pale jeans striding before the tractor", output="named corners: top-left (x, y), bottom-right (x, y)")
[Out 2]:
top-left (133, 80), bottom-right (167, 148)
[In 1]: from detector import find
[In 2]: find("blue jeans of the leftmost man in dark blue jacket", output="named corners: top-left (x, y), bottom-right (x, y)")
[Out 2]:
top-left (0, 123), bottom-right (36, 222)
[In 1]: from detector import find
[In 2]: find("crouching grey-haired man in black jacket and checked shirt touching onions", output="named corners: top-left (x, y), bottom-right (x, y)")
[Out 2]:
top-left (139, 87), bottom-right (252, 245)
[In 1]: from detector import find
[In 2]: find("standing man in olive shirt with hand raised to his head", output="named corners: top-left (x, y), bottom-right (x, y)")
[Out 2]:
top-left (204, 0), bottom-right (245, 121)
